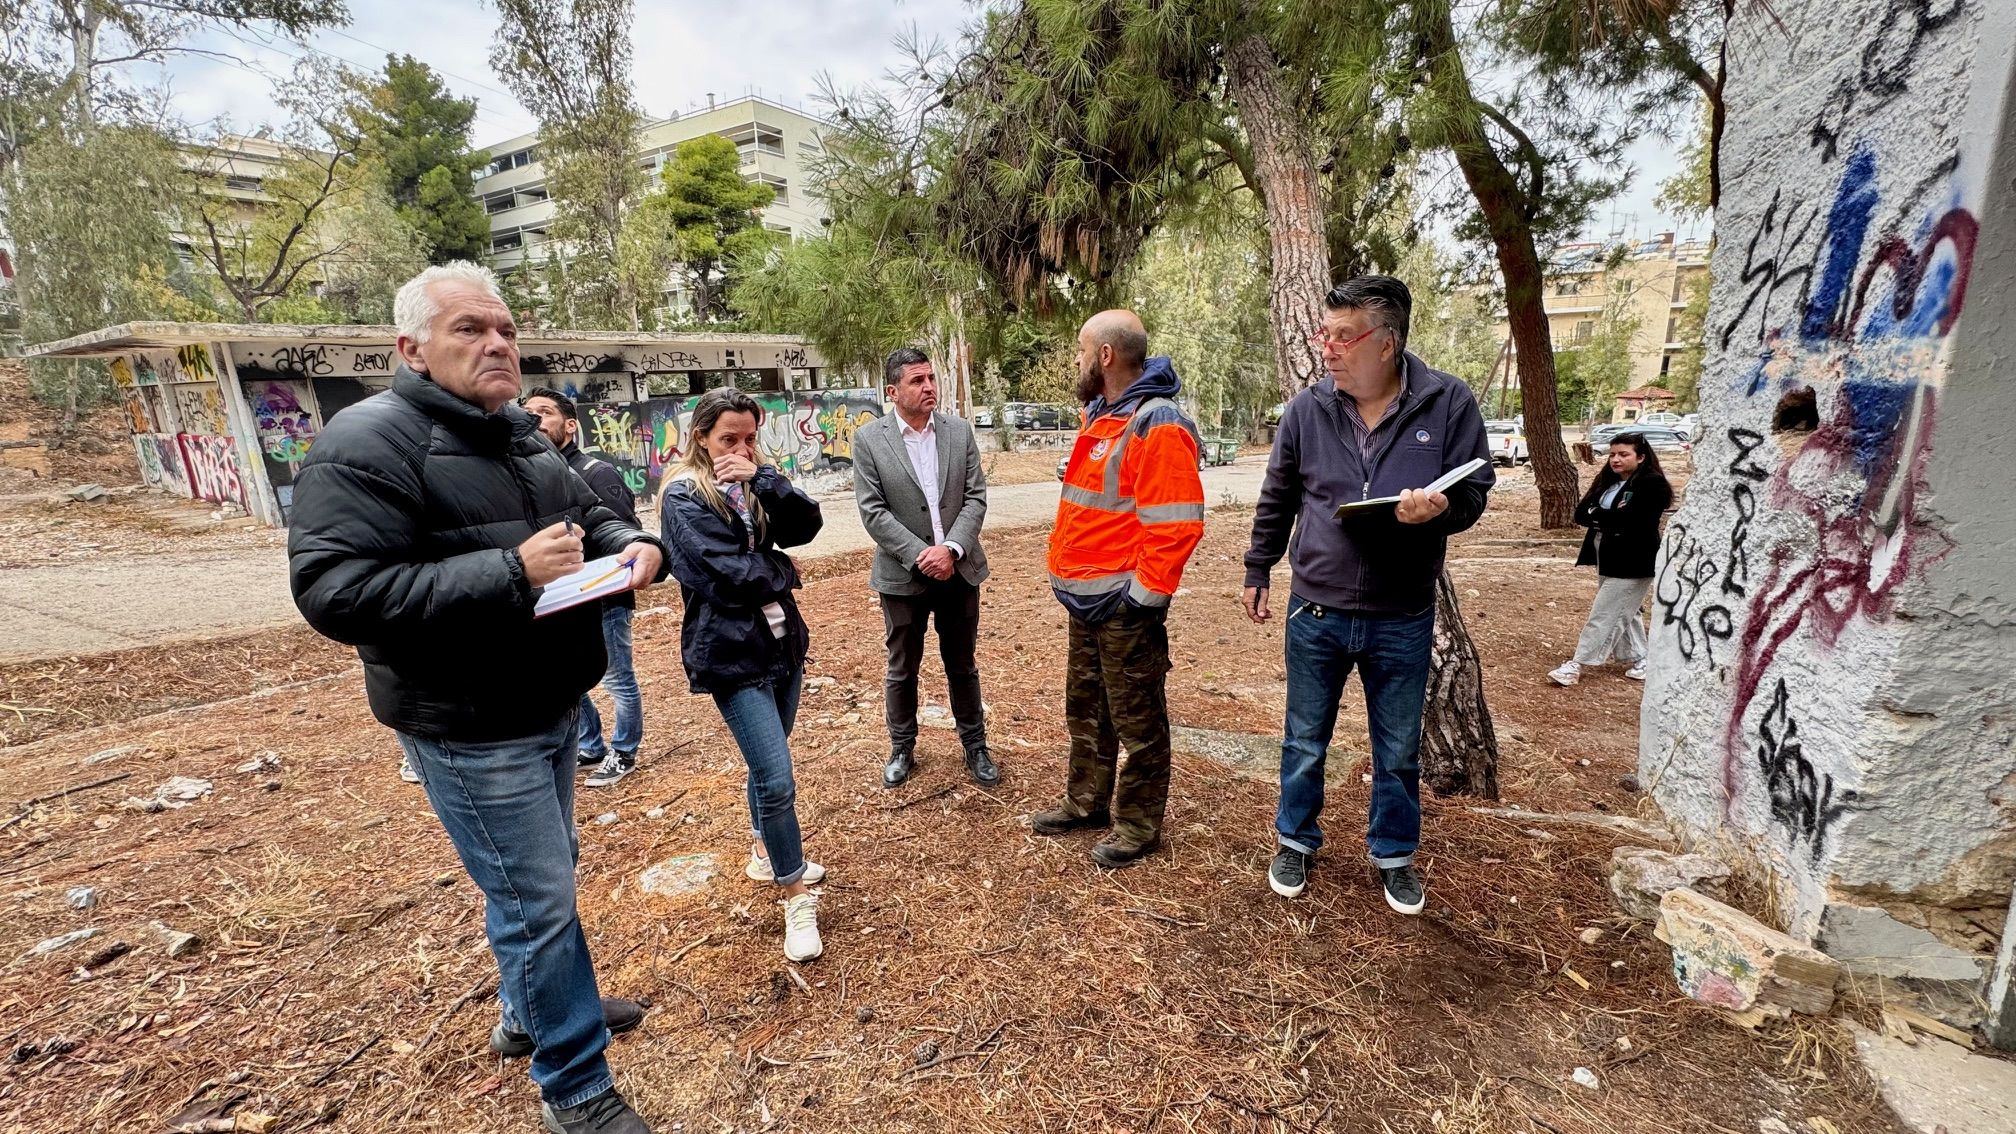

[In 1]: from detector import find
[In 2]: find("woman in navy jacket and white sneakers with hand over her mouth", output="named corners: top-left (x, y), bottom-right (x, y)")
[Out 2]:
top-left (659, 387), bottom-right (827, 960)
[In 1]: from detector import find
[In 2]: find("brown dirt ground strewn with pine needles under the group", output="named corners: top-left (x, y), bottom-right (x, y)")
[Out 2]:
top-left (0, 458), bottom-right (1897, 1134)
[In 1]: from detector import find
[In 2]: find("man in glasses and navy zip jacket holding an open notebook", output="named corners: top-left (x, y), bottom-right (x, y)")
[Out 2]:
top-left (1246, 276), bottom-right (1492, 914)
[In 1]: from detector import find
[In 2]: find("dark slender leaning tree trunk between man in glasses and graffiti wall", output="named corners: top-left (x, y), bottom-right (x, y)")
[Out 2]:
top-left (1423, 4), bottom-right (1579, 529)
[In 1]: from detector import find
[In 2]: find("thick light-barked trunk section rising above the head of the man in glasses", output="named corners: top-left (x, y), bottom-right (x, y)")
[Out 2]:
top-left (1226, 34), bottom-right (1331, 402)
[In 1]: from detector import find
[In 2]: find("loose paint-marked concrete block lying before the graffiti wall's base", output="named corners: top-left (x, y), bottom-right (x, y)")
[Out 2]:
top-left (1655, 888), bottom-right (1843, 1017)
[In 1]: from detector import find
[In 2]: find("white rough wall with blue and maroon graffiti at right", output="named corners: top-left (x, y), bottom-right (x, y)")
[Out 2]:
top-left (1641, 0), bottom-right (2016, 952)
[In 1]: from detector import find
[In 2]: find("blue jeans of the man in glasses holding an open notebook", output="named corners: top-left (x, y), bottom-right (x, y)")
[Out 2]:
top-left (1274, 597), bottom-right (1435, 868)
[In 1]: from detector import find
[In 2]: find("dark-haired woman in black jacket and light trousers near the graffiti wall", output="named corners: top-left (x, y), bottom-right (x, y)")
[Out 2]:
top-left (1546, 434), bottom-right (1673, 686)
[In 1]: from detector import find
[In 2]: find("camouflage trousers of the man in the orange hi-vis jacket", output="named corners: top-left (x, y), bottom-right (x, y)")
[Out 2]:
top-left (1064, 605), bottom-right (1169, 843)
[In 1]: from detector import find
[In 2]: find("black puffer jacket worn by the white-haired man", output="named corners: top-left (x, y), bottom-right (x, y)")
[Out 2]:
top-left (286, 367), bottom-right (657, 743)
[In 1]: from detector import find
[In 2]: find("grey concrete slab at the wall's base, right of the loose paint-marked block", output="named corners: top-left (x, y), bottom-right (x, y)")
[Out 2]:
top-left (1814, 902), bottom-right (1994, 1029)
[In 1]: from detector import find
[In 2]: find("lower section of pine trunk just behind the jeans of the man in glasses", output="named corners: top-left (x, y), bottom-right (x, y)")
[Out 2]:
top-left (1421, 569), bottom-right (1498, 799)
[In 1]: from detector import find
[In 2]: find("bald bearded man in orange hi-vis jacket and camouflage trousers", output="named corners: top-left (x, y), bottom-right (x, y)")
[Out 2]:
top-left (1030, 311), bottom-right (1204, 868)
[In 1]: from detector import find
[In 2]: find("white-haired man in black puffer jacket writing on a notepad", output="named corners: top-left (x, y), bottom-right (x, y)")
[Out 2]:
top-left (286, 262), bottom-right (665, 1134)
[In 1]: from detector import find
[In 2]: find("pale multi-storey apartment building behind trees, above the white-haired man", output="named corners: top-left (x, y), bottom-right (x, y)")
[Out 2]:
top-left (476, 95), bottom-right (827, 299)
